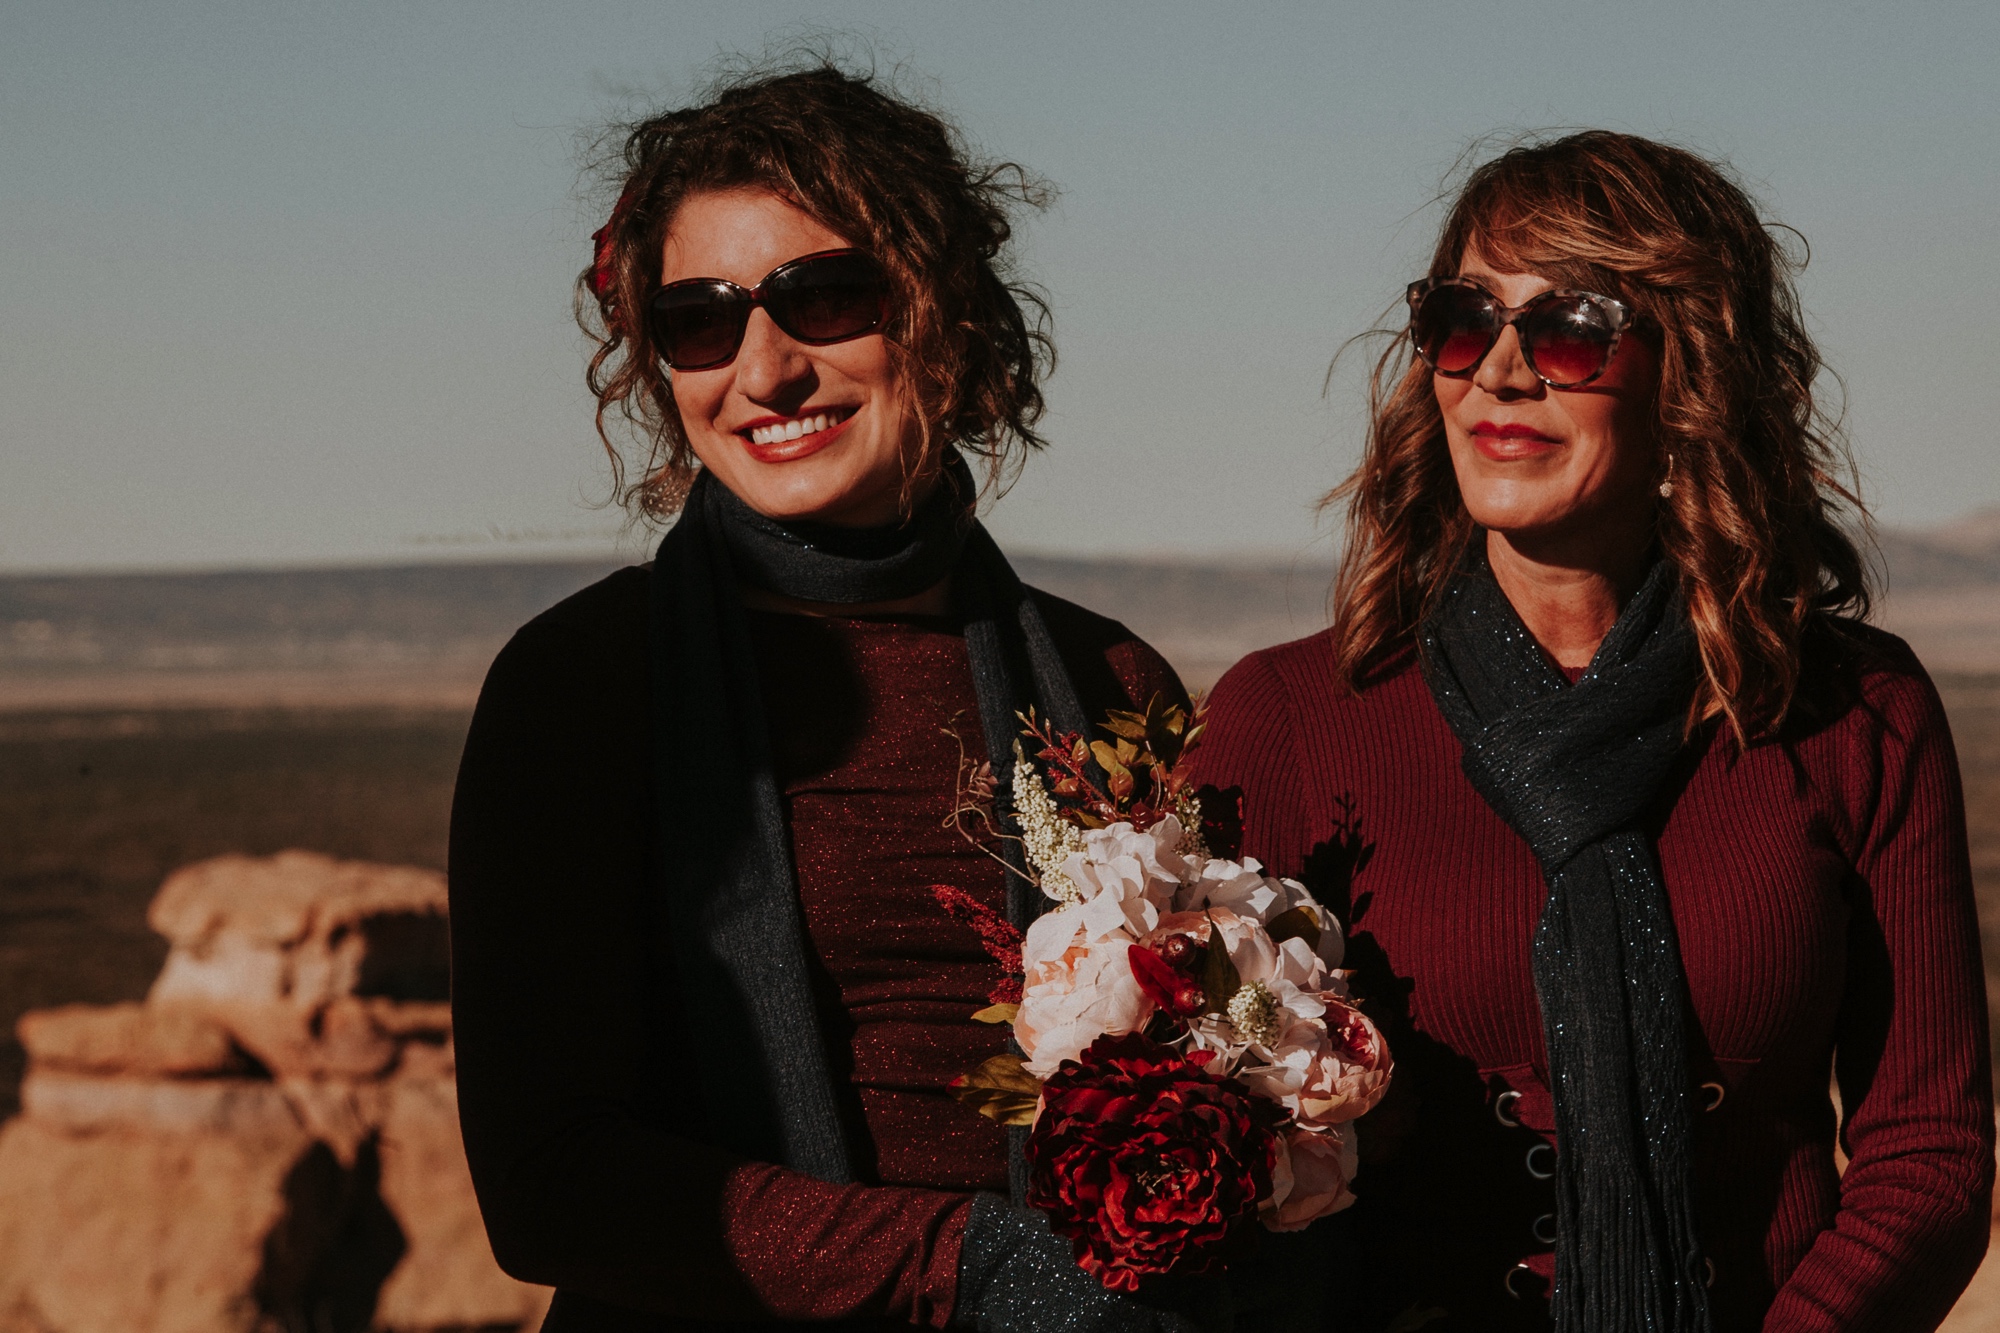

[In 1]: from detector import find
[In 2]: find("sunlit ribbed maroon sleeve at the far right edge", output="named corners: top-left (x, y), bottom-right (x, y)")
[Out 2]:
top-left (1764, 660), bottom-right (1994, 1333)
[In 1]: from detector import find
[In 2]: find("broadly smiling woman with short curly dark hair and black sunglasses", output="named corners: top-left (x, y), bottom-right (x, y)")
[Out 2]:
top-left (450, 66), bottom-right (1214, 1333)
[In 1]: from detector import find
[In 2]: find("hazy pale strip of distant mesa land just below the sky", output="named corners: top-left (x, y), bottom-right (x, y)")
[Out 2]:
top-left (0, 508), bottom-right (2000, 713)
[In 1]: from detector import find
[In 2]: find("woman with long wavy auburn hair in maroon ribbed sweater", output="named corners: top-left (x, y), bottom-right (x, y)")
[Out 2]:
top-left (1198, 132), bottom-right (1994, 1333)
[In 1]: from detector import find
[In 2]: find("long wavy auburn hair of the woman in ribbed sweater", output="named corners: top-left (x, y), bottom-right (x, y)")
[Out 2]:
top-left (1322, 130), bottom-right (1870, 741)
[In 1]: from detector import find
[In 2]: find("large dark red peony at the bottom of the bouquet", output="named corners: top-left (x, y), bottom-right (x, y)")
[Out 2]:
top-left (1028, 1033), bottom-right (1284, 1291)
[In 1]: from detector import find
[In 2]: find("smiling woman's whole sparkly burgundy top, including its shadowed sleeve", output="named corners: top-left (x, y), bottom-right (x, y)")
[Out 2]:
top-left (450, 568), bottom-right (1184, 1329)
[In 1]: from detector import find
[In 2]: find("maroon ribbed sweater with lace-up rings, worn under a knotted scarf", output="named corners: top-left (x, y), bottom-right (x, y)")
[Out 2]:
top-left (1196, 626), bottom-right (1994, 1333)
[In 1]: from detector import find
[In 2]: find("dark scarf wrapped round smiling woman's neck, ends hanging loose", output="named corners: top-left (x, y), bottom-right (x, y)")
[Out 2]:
top-left (652, 454), bottom-right (1084, 1183)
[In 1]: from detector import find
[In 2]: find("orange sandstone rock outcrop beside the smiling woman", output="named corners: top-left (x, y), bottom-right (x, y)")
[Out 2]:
top-left (0, 853), bottom-right (548, 1333)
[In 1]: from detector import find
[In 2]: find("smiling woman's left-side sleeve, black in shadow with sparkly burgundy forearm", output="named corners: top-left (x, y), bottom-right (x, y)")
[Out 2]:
top-left (450, 588), bottom-right (970, 1327)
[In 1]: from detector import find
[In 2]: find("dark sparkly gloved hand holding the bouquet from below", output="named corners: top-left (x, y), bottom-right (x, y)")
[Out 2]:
top-left (952, 1195), bottom-right (1236, 1333)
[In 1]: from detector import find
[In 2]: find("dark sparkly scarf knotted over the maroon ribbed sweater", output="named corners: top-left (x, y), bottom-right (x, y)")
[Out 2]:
top-left (1420, 556), bottom-right (1712, 1333)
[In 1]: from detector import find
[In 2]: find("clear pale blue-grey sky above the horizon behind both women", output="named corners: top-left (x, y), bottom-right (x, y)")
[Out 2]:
top-left (0, 0), bottom-right (2000, 570)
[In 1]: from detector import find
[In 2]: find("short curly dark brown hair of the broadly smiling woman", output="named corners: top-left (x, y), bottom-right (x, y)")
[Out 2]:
top-left (576, 60), bottom-right (1054, 514)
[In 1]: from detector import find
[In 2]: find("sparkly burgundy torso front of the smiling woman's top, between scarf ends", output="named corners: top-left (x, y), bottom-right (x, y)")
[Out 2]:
top-left (750, 614), bottom-right (1006, 1191)
